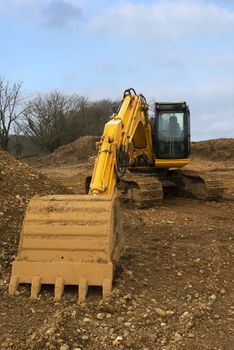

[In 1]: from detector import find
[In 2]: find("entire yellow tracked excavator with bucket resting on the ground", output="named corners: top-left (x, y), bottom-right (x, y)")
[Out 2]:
top-left (9, 89), bottom-right (223, 301)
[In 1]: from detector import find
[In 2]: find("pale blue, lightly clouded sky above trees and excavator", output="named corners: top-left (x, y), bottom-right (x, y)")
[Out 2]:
top-left (0, 0), bottom-right (234, 140)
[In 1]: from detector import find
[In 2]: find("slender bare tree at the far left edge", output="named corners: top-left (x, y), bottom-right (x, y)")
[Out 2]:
top-left (0, 77), bottom-right (24, 150)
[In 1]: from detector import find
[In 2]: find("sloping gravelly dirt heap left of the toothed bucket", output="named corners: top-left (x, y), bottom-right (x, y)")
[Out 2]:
top-left (0, 150), bottom-right (69, 272)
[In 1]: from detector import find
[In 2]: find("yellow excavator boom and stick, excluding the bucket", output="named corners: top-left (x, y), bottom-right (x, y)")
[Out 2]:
top-left (89, 89), bottom-right (154, 195)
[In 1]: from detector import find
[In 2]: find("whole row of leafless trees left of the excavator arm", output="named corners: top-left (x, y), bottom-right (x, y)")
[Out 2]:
top-left (0, 77), bottom-right (119, 153)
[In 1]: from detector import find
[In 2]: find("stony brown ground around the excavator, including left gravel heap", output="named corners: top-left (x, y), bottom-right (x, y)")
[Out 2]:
top-left (0, 138), bottom-right (234, 350)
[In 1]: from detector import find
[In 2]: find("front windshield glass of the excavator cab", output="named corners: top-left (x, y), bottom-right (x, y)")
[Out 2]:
top-left (158, 112), bottom-right (184, 158)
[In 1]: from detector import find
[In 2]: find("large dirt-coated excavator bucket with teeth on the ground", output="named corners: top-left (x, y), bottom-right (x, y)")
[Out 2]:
top-left (9, 195), bottom-right (123, 300)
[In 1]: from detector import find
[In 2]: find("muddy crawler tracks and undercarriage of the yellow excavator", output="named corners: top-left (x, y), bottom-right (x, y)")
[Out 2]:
top-left (117, 168), bottom-right (224, 204)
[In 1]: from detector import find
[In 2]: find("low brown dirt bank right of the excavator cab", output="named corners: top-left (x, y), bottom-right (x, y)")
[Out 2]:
top-left (192, 138), bottom-right (234, 161)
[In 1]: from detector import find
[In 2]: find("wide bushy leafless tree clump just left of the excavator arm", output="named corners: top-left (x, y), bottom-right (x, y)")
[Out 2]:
top-left (18, 90), bottom-right (118, 152)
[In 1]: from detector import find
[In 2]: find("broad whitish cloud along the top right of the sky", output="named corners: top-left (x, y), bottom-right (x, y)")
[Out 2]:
top-left (88, 0), bottom-right (234, 39)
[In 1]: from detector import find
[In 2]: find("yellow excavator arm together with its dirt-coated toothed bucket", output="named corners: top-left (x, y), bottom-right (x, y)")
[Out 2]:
top-left (9, 89), bottom-right (154, 300)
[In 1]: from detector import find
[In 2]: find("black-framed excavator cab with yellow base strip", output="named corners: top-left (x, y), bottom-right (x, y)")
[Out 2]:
top-left (154, 102), bottom-right (190, 168)
